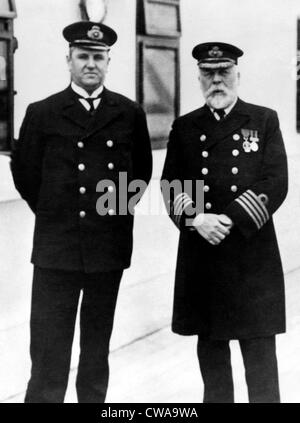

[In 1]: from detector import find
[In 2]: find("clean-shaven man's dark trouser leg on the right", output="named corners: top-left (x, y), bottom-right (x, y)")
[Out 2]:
top-left (76, 271), bottom-right (123, 403)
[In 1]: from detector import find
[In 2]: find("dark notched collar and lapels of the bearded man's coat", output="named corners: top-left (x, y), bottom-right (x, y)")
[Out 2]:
top-left (194, 99), bottom-right (250, 149)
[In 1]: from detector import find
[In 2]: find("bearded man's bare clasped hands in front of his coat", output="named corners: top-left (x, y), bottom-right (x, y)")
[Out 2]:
top-left (192, 213), bottom-right (233, 245)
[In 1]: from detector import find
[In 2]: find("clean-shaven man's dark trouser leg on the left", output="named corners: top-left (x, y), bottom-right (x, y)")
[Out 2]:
top-left (25, 267), bottom-right (80, 403)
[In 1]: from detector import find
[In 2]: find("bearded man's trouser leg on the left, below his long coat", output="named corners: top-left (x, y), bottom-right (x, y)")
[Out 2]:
top-left (197, 339), bottom-right (234, 403)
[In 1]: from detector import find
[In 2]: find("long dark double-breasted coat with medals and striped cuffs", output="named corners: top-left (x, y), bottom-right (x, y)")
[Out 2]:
top-left (162, 100), bottom-right (288, 339)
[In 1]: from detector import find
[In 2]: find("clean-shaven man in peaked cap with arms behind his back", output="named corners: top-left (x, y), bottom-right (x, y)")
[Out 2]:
top-left (12, 22), bottom-right (152, 403)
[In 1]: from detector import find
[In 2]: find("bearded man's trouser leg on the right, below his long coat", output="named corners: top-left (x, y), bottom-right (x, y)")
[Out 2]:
top-left (240, 336), bottom-right (280, 403)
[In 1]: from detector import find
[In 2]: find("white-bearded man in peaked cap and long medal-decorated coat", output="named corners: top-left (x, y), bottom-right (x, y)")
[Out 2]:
top-left (162, 42), bottom-right (288, 403)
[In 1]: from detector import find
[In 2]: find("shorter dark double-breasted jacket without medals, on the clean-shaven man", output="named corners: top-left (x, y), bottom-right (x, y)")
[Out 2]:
top-left (12, 86), bottom-right (152, 272)
